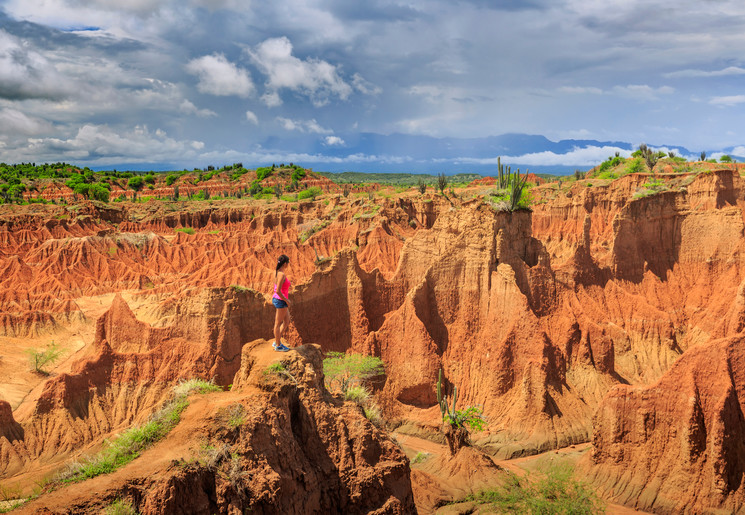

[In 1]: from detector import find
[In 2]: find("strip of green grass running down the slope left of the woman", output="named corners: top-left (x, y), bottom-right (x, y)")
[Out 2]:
top-left (59, 379), bottom-right (222, 483)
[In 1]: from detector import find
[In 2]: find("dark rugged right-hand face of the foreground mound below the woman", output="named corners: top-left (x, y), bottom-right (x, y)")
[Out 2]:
top-left (184, 345), bottom-right (415, 513)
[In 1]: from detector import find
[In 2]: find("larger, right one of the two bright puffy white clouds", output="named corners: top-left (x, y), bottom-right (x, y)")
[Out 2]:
top-left (247, 37), bottom-right (352, 107)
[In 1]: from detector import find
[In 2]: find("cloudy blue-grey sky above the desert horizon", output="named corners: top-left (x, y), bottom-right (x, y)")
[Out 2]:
top-left (0, 0), bottom-right (745, 173)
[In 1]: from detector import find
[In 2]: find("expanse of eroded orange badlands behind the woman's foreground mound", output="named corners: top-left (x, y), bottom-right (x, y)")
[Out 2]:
top-left (0, 170), bottom-right (745, 512)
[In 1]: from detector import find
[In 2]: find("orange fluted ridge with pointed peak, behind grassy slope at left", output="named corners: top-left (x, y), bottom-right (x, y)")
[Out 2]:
top-left (0, 288), bottom-right (273, 476)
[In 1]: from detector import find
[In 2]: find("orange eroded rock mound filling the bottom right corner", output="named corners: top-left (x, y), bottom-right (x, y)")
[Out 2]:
top-left (583, 334), bottom-right (745, 513)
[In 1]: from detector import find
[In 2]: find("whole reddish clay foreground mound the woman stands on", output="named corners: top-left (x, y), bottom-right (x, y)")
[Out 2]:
top-left (18, 340), bottom-right (415, 514)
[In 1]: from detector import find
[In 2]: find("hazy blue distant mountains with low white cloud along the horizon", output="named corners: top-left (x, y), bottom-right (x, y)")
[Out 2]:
top-left (261, 133), bottom-right (745, 175)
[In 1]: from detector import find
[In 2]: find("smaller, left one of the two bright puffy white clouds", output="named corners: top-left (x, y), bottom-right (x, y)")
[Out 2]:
top-left (186, 54), bottom-right (254, 97)
